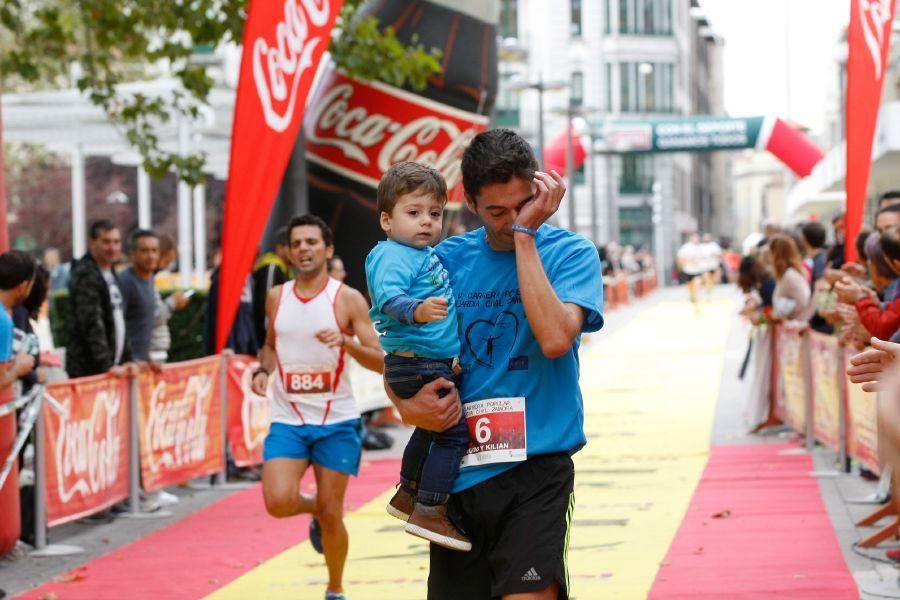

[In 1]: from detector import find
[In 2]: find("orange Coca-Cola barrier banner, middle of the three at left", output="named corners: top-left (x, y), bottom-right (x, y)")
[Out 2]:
top-left (138, 356), bottom-right (225, 492)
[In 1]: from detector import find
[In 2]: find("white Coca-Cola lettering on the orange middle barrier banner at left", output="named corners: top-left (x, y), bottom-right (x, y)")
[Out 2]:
top-left (144, 374), bottom-right (213, 472)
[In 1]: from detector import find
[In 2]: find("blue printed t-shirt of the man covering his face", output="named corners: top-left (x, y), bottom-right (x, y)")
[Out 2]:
top-left (436, 225), bottom-right (603, 492)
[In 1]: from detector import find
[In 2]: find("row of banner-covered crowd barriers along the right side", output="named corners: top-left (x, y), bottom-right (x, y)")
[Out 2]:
top-left (769, 325), bottom-right (881, 473)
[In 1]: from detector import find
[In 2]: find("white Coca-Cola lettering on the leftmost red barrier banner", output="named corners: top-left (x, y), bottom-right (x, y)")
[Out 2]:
top-left (56, 390), bottom-right (122, 503)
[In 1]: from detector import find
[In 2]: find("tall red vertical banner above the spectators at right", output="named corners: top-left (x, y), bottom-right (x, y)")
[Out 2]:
top-left (844, 0), bottom-right (894, 261)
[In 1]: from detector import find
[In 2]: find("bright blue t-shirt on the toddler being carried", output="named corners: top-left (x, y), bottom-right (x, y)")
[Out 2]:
top-left (366, 240), bottom-right (459, 358)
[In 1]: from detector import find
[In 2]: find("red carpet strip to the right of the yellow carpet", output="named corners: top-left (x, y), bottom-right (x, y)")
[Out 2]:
top-left (650, 444), bottom-right (859, 600)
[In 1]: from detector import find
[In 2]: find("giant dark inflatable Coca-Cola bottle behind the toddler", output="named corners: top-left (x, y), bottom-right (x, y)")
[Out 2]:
top-left (304, 0), bottom-right (497, 290)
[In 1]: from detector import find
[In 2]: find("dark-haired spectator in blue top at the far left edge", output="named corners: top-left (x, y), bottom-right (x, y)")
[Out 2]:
top-left (0, 250), bottom-right (36, 395)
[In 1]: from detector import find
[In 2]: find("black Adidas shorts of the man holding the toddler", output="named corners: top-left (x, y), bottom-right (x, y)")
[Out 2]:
top-left (428, 453), bottom-right (575, 600)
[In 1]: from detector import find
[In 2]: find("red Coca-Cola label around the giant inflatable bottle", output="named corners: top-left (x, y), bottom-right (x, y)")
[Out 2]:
top-left (304, 65), bottom-right (489, 202)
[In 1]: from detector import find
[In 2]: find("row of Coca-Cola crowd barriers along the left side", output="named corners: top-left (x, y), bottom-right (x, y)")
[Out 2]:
top-left (0, 355), bottom-right (270, 550)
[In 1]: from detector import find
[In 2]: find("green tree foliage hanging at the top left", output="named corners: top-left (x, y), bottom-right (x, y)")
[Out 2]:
top-left (0, 0), bottom-right (441, 185)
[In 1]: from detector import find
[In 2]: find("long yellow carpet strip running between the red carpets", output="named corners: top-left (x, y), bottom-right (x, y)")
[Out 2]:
top-left (210, 302), bottom-right (735, 600)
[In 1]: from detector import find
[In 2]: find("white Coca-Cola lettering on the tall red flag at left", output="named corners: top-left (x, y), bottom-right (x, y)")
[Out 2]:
top-left (252, 0), bottom-right (331, 133)
